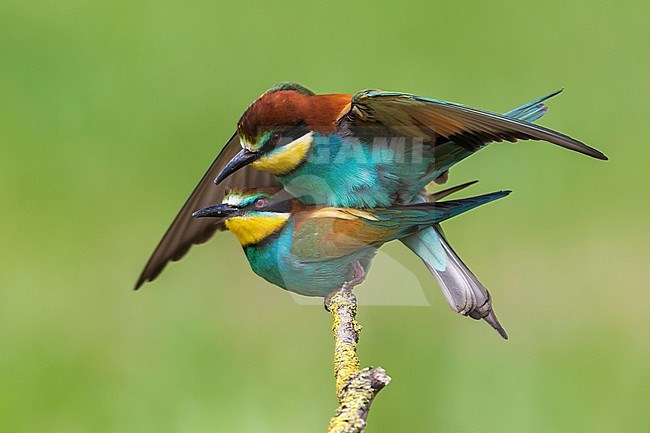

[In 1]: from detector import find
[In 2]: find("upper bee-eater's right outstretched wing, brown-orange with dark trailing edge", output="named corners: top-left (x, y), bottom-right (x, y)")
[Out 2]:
top-left (338, 90), bottom-right (607, 159)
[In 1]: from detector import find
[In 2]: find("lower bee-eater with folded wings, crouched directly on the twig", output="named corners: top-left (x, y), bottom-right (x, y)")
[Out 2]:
top-left (193, 189), bottom-right (509, 338)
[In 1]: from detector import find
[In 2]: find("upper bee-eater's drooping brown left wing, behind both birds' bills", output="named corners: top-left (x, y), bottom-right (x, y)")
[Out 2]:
top-left (135, 134), bottom-right (281, 290)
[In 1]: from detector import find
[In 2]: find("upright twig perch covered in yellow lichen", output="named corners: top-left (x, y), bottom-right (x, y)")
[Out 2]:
top-left (325, 287), bottom-right (390, 433)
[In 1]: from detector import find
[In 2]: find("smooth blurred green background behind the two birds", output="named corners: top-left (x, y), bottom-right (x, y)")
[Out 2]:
top-left (0, 0), bottom-right (650, 433)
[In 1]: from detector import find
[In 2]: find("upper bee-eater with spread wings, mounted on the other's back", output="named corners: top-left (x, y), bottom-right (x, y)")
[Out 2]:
top-left (136, 83), bottom-right (606, 334)
